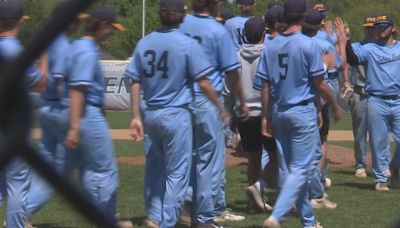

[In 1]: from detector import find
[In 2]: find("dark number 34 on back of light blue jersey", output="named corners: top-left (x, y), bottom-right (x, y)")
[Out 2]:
top-left (143, 50), bottom-right (168, 78)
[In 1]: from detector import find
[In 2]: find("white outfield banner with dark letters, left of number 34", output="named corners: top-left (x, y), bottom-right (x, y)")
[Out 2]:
top-left (101, 60), bottom-right (130, 110)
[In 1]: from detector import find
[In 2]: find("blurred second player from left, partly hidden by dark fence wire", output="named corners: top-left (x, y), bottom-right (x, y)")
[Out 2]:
top-left (27, 2), bottom-right (85, 216)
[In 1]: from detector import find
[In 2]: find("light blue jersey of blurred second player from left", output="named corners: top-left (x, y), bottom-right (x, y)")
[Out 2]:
top-left (42, 33), bottom-right (70, 101)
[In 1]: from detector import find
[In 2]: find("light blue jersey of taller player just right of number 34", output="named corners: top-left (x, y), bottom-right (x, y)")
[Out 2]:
top-left (180, 14), bottom-right (240, 93)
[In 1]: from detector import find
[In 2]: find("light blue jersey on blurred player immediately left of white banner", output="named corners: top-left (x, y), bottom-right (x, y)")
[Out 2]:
top-left (66, 38), bottom-right (105, 107)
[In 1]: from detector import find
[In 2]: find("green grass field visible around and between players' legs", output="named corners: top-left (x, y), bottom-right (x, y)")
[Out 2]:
top-left (14, 112), bottom-right (400, 228)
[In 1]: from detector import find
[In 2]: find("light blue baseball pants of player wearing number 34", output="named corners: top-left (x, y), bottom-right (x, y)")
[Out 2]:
top-left (144, 107), bottom-right (193, 227)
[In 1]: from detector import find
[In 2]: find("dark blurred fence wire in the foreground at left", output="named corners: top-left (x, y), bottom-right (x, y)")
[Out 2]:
top-left (0, 0), bottom-right (116, 228)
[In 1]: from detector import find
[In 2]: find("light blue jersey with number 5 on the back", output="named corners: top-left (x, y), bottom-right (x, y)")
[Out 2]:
top-left (257, 32), bottom-right (325, 106)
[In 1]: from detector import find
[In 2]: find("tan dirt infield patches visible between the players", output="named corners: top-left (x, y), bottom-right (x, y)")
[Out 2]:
top-left (33, 129), bottom-right (364, 167)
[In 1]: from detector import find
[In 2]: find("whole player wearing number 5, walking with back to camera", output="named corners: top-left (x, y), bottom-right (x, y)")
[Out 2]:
top-left (257, 0), bottom-right (341, 227)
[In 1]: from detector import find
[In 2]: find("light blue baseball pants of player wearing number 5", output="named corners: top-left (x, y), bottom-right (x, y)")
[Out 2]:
top-left (271, 103), bottom-right (320, 227)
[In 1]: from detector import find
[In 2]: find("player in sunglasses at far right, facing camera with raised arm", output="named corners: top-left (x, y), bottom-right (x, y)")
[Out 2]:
top-left (341, 14), bottom-right (400, 192)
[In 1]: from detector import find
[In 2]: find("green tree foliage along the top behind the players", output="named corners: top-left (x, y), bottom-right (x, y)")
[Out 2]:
top-left (21, 0), bottom-right (400, 59)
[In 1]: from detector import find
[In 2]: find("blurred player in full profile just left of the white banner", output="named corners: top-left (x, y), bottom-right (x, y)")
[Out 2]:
top-left (65, 7), bottom-right (124, 223)
